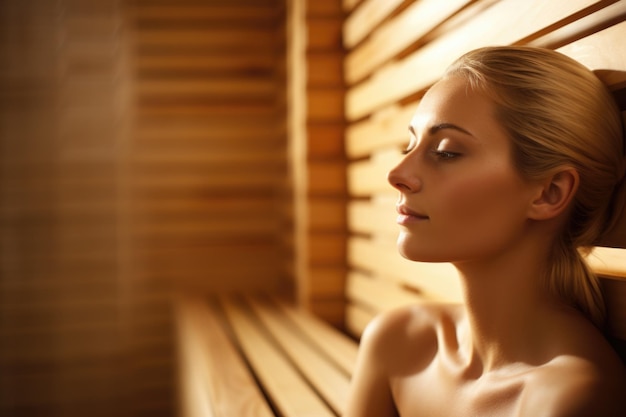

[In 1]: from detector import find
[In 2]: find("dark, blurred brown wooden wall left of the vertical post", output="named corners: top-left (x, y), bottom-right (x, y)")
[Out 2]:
top-left (0, 0), bottom-right (294, 416)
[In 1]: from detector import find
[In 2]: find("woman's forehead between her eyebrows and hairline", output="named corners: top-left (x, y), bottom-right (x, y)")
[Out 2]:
top-left (411, 76), bottom-right (501, 137)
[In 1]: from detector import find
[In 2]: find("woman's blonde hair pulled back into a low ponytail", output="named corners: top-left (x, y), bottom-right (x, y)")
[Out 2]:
top-left (446, 46), bottom-right (625, 328)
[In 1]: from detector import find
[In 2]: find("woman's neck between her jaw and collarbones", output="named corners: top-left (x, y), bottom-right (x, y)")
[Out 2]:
top-left (455, 239), bottom-right (558, 372)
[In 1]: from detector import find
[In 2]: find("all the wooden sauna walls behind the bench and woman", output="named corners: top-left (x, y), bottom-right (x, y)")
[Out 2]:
top-left (0, 0), bottom-right (626, 417)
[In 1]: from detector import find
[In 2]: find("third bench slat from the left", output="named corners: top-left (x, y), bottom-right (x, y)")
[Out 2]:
top-left (246, 297), bottom-right (350, 415)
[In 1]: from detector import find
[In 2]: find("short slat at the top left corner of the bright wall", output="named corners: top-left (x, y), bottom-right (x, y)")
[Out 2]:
top-left (343, 0), bottom-right (404, 49)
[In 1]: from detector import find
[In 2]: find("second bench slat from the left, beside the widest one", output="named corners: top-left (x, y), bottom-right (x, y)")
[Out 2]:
top-left (222, 299), bottom-right (335, 417)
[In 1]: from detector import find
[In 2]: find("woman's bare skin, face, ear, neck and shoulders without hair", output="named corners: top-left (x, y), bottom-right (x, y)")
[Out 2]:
top-left (345, 77), bottom-right (626, 417)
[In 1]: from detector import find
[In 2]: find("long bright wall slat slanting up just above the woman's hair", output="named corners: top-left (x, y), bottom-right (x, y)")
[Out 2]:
top-left (346, 0), bottom-right (602, 120)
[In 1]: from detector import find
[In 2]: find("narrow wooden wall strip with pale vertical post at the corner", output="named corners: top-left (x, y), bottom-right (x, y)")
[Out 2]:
top-left (287, 0), bottom-right (346, 326)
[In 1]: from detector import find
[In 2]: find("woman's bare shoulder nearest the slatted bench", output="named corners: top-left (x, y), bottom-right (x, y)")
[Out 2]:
top-left (361, 303), bottom-right (462, 376)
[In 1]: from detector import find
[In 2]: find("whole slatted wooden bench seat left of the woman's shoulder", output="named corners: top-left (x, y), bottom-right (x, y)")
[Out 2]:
top-left (176, 295), bottom-right (357, 417)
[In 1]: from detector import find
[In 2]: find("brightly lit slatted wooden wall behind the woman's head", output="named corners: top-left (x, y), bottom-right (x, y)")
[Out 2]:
top-left (343, 0), bottom-right (626, 335)
